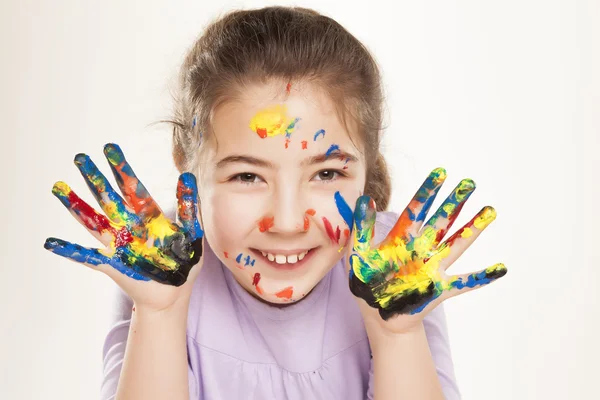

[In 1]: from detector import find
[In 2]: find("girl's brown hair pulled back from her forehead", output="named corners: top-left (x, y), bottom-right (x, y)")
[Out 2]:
top-left (166, 6), bottom-right (391, 211)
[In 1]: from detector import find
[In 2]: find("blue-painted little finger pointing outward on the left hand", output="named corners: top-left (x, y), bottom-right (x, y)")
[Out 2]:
top-left (44, 238), bottom-right (150, 281)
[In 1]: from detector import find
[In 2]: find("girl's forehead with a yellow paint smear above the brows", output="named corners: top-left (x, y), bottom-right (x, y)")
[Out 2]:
top-left (213, 83), bottom-right (360, 162)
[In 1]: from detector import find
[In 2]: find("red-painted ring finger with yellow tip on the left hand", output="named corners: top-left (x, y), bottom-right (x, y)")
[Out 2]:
top-left (52, 182), bottom-right (119, 246)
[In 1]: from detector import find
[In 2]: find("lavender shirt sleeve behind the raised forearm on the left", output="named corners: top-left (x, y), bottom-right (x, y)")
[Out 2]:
top-left (100, 287), bottom-right (200, 400)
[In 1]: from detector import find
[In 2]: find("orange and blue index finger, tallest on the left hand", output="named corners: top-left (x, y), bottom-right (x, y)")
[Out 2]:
top-left (104, 143), bottom-right (162, 221)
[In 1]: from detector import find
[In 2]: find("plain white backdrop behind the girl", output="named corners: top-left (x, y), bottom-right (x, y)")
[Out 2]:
top-left (0, 0), bottom-right (600, 400)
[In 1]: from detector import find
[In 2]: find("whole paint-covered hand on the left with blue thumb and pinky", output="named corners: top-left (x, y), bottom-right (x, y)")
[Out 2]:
top-left (44, 143), bottom-right (204, 311)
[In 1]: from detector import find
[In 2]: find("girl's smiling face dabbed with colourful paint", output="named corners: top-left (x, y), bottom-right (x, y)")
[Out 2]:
top-left (200, 80), bottom-right (366, 303)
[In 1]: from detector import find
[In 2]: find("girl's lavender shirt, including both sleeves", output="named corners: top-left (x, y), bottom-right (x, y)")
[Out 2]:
top-left (101, 212), bottom-right (460, 400)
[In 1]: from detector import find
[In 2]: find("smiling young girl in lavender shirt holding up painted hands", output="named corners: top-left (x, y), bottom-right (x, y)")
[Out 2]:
top-left (45, 7), bottom-right (506, 400)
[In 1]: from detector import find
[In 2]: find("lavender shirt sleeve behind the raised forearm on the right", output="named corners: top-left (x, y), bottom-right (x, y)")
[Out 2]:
top-left (367, 303), bottom-right (461, 400)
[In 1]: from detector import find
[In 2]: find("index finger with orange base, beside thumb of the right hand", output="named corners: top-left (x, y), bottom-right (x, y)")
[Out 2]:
top-left (384, 167), bottom-right (446, 244)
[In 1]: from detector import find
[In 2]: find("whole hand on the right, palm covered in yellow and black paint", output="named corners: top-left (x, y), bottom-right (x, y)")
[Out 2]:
top-left (349, 168), bottom-right (506, 320)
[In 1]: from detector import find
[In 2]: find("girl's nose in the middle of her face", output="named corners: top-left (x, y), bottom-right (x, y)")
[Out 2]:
top-left (269, 185), bottom-right (306, 233)
